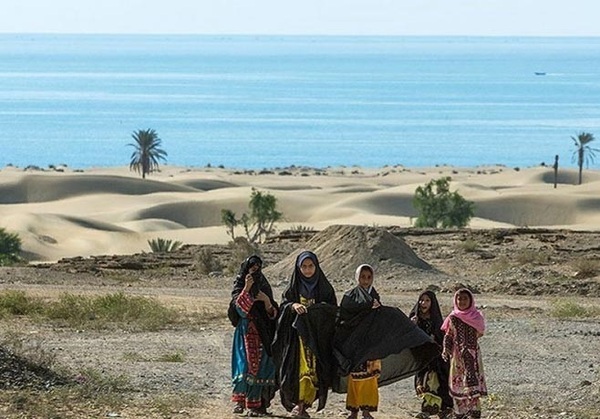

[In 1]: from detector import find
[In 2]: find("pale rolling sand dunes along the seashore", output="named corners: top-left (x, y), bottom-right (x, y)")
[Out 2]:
top-left (0, 166), bottom-right (600, 261)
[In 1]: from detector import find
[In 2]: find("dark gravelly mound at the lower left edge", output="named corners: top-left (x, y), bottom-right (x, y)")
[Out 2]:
top-left (0, 346), bottom-right (68, 390)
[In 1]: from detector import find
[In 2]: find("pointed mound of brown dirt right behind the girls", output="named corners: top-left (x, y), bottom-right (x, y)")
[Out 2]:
top-left (265, 225), bottom-right (432, 285)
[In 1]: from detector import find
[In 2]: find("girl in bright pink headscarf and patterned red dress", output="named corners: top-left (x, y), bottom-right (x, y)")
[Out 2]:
top-left (442, 288), bottom-right (487, 419)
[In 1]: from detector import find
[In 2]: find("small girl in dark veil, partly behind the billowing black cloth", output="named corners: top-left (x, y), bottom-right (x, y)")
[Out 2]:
top-left (409, 291), bottom-right (452, 419)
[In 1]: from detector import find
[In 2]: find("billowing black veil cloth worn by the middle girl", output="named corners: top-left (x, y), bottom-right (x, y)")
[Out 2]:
top-left (332, 286), bottom-right (439, 393)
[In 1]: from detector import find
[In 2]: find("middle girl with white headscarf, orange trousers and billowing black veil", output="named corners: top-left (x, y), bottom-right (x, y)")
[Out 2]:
top-left (333, 265), bottom-right (439, 419)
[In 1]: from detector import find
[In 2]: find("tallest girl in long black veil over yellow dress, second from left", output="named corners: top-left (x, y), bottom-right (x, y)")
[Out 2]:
top-left (273, 251), bottom-right (337, 418)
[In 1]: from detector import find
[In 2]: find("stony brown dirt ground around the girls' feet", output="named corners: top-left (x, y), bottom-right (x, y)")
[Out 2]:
top-left (0, 227), bottom-right (600, 419)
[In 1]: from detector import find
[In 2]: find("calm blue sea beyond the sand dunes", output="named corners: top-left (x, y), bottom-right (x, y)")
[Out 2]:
top-left (0, 34), bottom-right (600, 168)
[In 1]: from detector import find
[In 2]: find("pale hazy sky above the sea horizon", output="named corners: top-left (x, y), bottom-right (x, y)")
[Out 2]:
top-left (0, 0), bottom-right (600, 36)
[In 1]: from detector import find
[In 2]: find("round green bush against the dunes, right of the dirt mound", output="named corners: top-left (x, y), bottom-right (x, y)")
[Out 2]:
top-left (413, 177), bottom-right (475, 228)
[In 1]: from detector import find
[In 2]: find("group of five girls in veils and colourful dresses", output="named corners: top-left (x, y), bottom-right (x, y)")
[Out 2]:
top-left (228, 251), bottom-right (487, 419)
